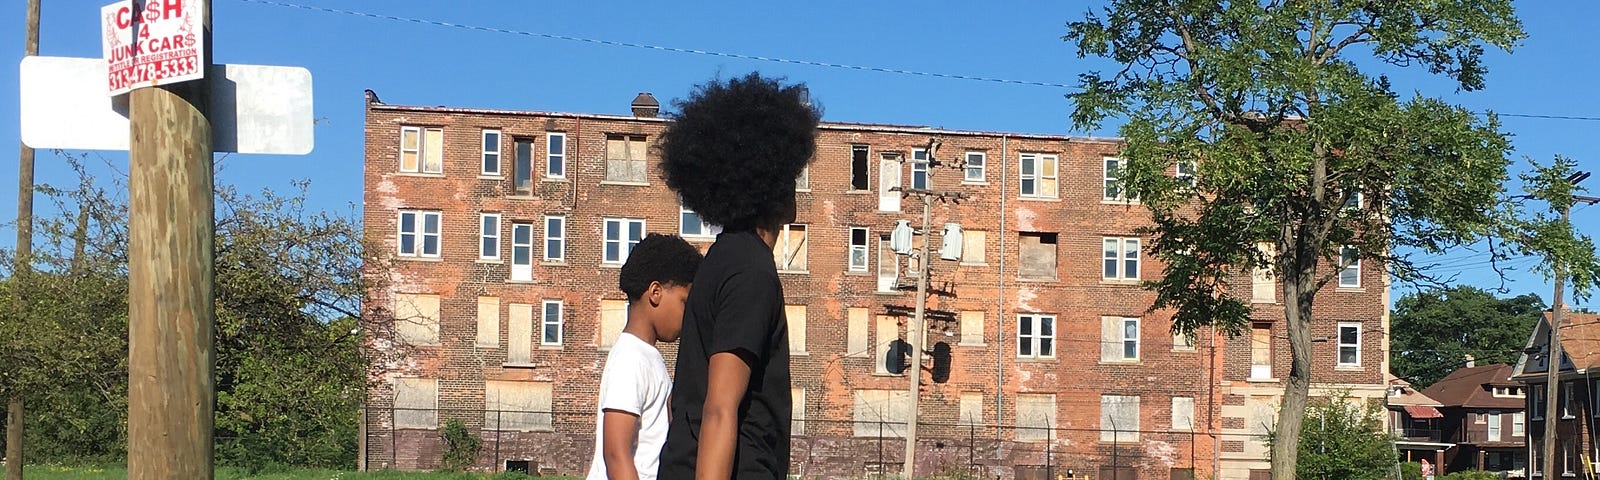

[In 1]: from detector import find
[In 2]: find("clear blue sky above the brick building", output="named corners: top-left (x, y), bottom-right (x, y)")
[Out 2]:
top-left (0, 0), bottom-right (1600, 307)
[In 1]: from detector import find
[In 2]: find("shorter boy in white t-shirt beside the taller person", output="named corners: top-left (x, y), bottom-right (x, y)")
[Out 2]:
top-left (589, 234), bottom-right (701, 480)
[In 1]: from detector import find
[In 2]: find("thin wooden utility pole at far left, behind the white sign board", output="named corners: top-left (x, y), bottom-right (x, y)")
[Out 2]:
top-left (5, 0), bottom-right (40, 480)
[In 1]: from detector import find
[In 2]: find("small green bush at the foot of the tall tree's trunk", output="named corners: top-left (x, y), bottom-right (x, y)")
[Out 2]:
top-left (1274, 394), bottom-right (1395, 480)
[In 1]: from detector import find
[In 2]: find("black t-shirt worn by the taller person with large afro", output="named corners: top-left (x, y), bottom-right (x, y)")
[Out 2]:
top-left (658, 232), bottom-right (790, 480)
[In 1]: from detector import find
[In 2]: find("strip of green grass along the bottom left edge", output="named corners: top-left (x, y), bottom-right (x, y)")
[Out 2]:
top-left (24, 466), bottom-right (582, 480)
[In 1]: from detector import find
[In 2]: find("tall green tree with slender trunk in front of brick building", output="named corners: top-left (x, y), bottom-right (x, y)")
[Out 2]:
top-left (1066, 0), bottom-right (1523, 478)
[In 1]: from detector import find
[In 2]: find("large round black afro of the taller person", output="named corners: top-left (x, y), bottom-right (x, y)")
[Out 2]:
top-left (659, 72), bottom-right (822, 230)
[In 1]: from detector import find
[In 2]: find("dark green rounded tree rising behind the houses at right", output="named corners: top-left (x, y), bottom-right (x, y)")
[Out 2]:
top-left (1389, 285), bottom-right (1546, 389)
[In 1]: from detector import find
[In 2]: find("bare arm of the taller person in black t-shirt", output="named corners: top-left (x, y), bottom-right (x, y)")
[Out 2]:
top-left (694, 352), bottom-right (750, 480)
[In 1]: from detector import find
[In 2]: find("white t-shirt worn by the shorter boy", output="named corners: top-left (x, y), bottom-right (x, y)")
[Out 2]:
top-left (589, 333), bottom-right (672, 480)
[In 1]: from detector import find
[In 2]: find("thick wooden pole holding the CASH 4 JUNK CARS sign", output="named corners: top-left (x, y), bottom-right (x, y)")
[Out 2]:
top-left (128, 0), bottom-right (214, 480)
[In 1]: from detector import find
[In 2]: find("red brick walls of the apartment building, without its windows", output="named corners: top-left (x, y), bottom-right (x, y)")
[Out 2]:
top-left (363, 93), bottom-right (1387, 478)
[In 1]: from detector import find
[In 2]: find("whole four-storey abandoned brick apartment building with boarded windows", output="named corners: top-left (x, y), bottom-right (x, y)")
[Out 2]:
top-left (360, 93), bottom-right (1389, 478)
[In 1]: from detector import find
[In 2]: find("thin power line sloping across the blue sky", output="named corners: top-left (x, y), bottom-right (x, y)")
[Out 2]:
top-left (238, 0), bottom-right (1600, 122)
